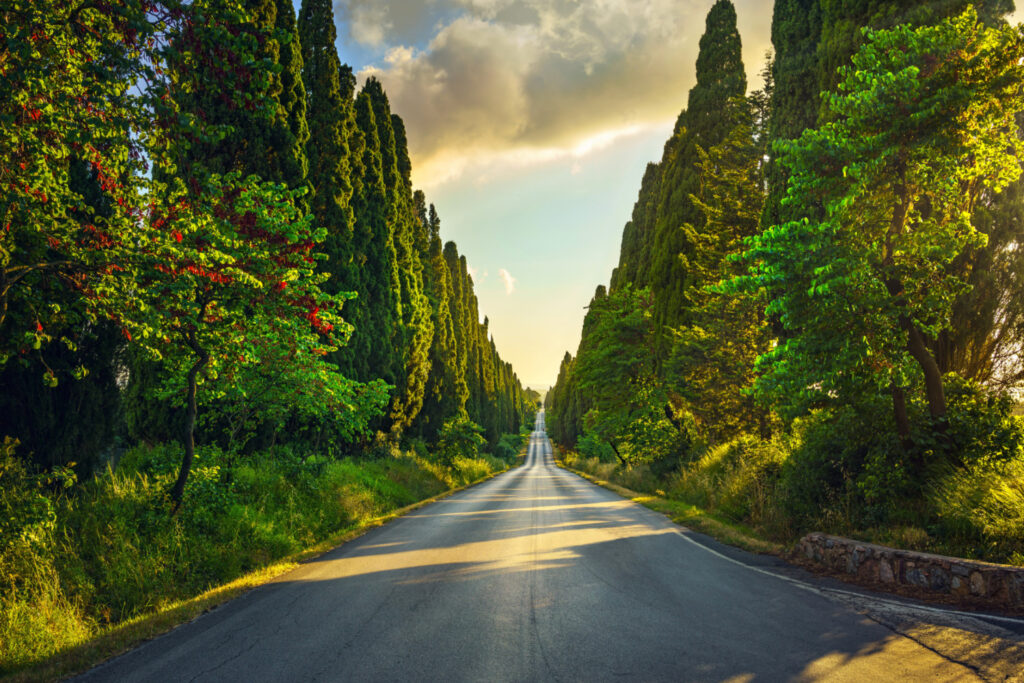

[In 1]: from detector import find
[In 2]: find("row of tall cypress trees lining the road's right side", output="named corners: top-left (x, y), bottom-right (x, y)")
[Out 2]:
top-left (546, 0), bottom-right (1024, 454)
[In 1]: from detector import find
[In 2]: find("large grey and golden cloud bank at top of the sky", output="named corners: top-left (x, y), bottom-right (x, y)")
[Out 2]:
top-left (345, 0), bottom-right (771, 188)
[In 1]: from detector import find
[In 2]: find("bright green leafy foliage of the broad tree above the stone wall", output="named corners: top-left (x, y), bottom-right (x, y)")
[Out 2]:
top-left (740, 7), bottom-right (1024, 430)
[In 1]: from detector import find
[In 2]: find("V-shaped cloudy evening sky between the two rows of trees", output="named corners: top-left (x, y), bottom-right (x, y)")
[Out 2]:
top-left (296, 0), bottom-right (1024, 388)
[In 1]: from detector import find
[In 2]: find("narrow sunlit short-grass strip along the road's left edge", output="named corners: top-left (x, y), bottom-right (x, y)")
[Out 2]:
top-left (12, 454), bottom-right (528, 683)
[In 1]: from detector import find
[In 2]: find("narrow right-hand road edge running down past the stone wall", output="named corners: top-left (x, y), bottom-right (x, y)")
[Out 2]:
top-left (553, 450), bottom-right (1024, 634)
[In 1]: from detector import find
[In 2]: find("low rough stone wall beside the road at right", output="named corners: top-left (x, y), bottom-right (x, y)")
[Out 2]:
top-left (797, 533), bottom-right (1024, 608)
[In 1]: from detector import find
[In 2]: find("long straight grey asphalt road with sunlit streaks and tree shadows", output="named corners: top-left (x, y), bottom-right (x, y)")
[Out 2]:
top-left (81, 415), bottom-right (1020, 682)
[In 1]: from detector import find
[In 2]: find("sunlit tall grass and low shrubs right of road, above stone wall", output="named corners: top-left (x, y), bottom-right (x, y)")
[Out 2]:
top-left (563, 428), bottom-right (1024, 565)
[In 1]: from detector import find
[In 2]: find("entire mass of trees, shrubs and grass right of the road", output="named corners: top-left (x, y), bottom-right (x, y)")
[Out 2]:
top-left (546, 0), bottom-right (1024, 565)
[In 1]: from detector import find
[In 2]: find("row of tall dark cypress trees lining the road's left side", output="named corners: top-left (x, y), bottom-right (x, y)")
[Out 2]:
top-left (6, 0), bottom-right (528, 466)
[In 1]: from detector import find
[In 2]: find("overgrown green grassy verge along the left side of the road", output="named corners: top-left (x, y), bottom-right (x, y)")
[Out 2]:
top-left (0, 446), bottom-right (515, 681)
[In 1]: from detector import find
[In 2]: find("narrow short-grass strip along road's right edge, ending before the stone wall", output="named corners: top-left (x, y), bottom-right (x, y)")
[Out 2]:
top-left (556, 459), bottom-right (786, 555)
